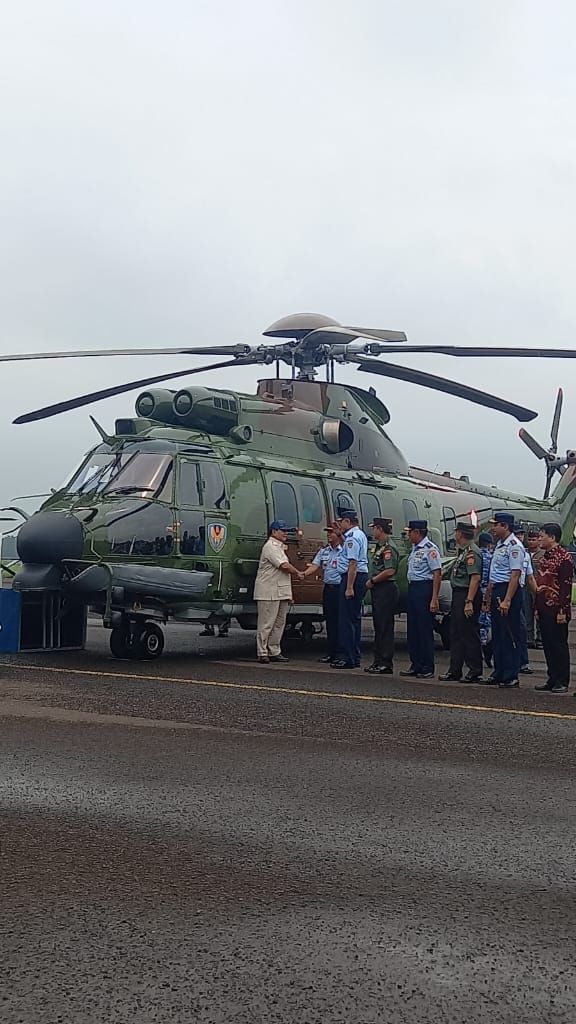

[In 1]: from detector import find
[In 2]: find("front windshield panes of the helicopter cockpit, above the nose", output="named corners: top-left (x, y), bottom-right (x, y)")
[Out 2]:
top-left (66, 452), bottom-right (172, 502)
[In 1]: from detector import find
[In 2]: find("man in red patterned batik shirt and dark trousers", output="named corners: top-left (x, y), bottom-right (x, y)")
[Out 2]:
top-left (536, 522), bottom-right (574, 693)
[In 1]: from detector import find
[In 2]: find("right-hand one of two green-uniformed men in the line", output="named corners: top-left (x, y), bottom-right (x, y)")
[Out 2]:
top-left (440, 522), bottom-right (482, 683)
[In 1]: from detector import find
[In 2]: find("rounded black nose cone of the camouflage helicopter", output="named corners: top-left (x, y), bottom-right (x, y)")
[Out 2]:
top-left (16, 512), bottom-right (84, 565)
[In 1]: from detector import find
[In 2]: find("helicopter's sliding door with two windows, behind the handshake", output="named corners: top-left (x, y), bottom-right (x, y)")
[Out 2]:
top-left (265, 473), bottom-right (326, 607)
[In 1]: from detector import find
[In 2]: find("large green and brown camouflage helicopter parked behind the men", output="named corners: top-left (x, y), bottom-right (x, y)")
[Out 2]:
top-left (0, 313), bottom-right (576, 659)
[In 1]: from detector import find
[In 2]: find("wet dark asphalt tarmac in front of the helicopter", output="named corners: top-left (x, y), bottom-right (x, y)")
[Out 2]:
top-left (0, 628), bottom-right (576, 1024)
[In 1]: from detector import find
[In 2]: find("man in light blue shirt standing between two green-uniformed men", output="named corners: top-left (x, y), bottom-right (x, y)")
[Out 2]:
top-left (400, 519), bottom-right (442, 679)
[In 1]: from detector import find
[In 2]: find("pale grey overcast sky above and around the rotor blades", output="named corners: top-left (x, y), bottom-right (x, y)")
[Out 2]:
top-left (0, 0), bottom-right (576, 520)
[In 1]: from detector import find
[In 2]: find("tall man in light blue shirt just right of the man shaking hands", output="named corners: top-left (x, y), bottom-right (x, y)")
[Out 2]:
top-left (332, 508), bottom-right (368, 669)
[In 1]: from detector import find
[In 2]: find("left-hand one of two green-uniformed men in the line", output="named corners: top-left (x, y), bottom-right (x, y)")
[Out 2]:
top-left (364, 519), bottom-right (400, 676)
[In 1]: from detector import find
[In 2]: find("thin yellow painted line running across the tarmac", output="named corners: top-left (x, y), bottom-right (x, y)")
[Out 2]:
top-left (10, 664), bottom-right (576, 722)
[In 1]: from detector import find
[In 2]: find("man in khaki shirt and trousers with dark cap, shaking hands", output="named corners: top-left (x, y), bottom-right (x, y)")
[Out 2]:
top-left (254, 519), bottom-right (303, 663)
